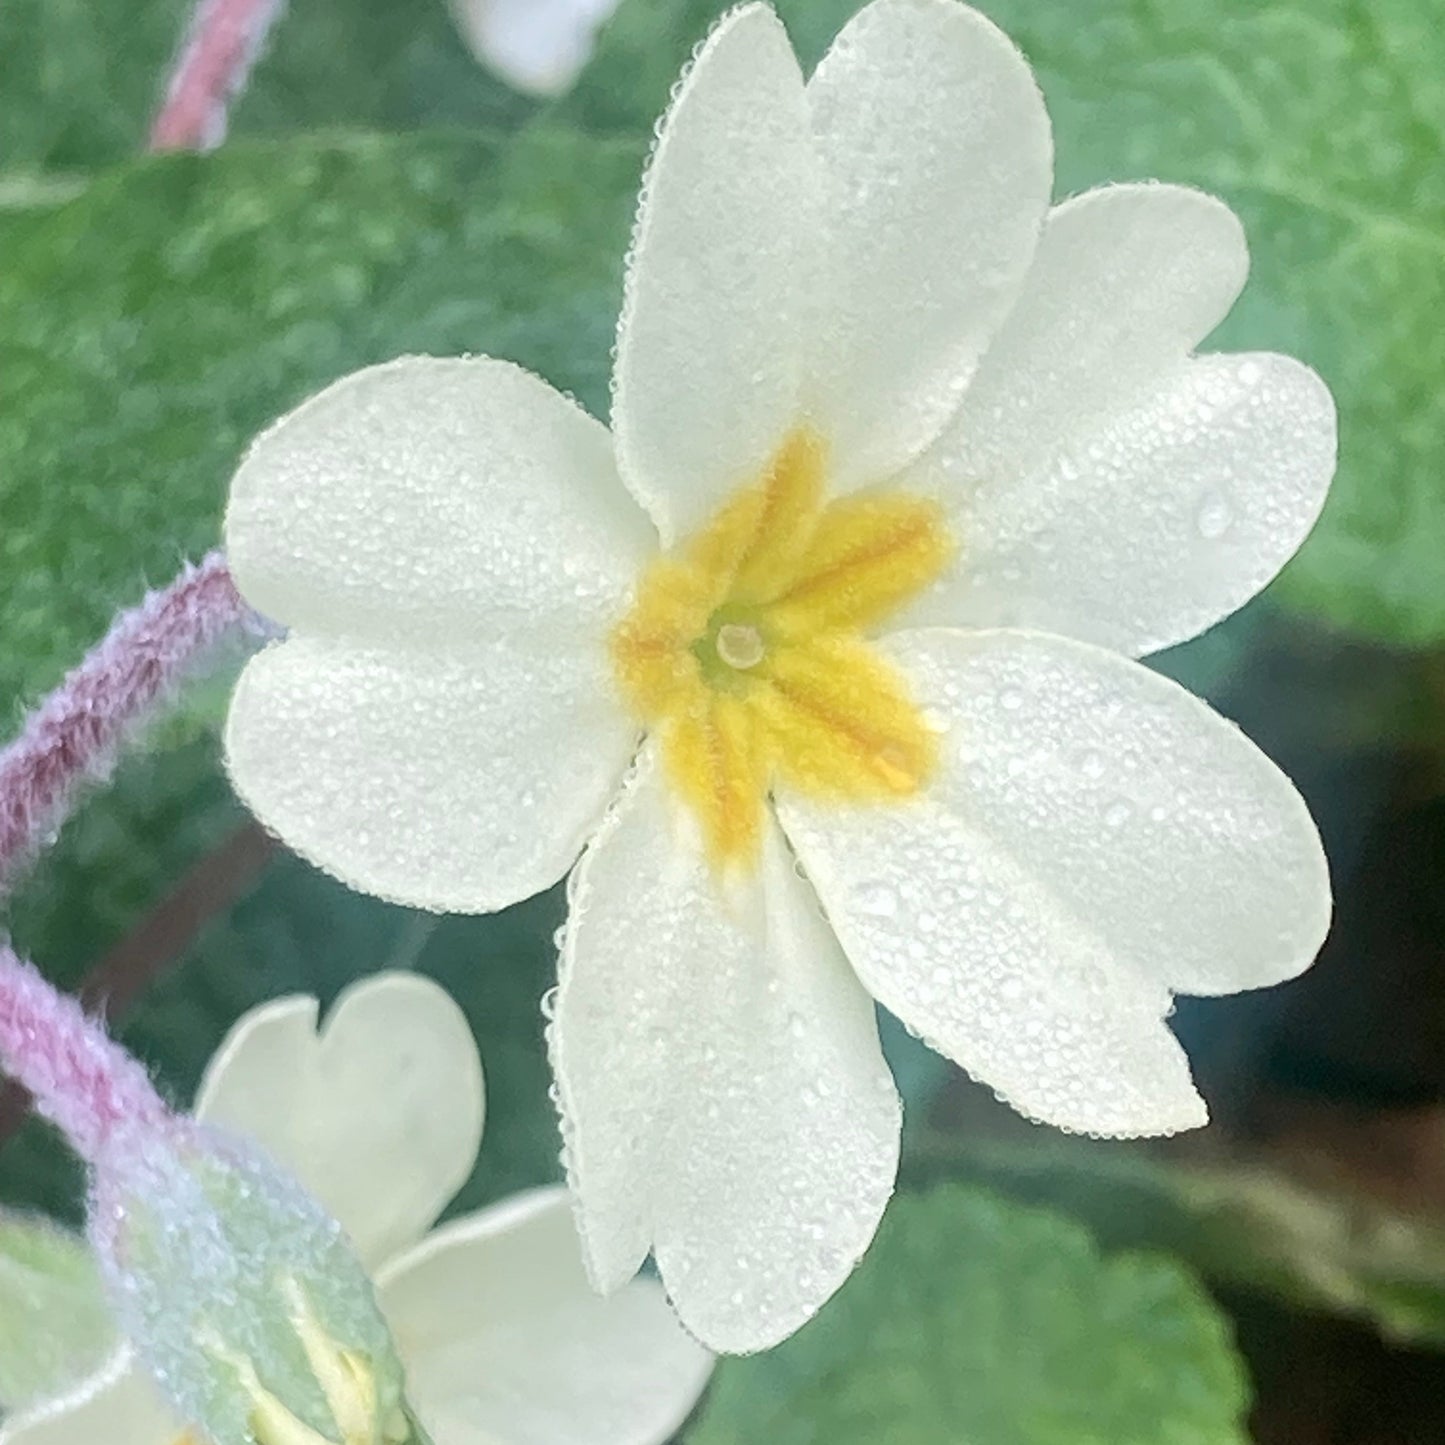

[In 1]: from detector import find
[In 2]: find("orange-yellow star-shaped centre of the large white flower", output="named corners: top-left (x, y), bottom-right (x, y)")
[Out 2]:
top-left (611, 431), bottom-right (954, 867)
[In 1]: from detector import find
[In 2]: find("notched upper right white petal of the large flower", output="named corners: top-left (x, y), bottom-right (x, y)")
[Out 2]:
top-left (903, 185), bottom-right (1335, 656)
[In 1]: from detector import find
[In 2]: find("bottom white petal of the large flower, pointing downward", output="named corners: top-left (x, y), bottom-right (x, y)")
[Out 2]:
top-left (552, 750), bottom-right (899, 1351)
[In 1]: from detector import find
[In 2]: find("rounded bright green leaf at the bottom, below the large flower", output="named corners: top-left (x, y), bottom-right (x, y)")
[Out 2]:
top-left (688, 1185), bottom-right (1248, 1445)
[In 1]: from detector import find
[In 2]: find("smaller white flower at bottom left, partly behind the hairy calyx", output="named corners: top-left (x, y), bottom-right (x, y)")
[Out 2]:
top-left (0, 972), bottom-right (711, 1445)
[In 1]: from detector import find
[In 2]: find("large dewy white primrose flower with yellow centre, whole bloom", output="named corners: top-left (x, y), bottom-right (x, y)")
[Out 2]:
top-left (227, 0), bottom-right (1335, 1350)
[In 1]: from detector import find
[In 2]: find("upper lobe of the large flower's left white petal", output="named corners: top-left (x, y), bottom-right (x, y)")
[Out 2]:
top-left (225, 357), bottom-right (656, 646)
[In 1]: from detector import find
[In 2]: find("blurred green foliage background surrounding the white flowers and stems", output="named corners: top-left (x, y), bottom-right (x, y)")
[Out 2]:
top-left (0, 0), bottom-right (1445, 1445)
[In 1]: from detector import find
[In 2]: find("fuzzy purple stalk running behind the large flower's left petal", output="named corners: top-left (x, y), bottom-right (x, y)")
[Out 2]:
top-left (0, 552), bottom-right (267, 883)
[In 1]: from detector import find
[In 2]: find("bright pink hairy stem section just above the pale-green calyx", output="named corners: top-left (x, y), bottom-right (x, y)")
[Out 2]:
top-left (0, 945), bottom-right (171, 1163)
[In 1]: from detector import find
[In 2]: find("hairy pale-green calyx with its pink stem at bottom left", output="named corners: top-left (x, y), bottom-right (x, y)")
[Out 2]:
top-left (0, 946), bottom-right (419, 1445)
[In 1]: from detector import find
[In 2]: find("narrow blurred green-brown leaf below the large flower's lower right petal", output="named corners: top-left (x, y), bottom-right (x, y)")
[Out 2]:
top-left (916, 1133), bottom-right (1445, 1348)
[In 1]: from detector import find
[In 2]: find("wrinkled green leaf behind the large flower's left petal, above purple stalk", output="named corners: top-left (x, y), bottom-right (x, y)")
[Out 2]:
top-left (0, 133), bottom-right (640, 708)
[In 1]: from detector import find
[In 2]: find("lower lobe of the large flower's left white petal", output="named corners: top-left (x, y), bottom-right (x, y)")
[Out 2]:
top-left (225, 636), bottom-right (637, 913)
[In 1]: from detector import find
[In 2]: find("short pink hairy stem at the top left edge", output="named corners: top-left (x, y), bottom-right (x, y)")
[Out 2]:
top-left (150, 0), bottom-right (283, 150)
